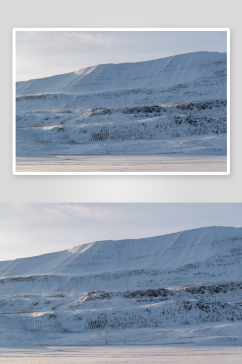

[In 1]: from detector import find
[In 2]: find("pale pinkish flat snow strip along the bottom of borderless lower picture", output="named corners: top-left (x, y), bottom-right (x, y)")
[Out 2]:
top-left (0, 346), bottom-right (242, 364)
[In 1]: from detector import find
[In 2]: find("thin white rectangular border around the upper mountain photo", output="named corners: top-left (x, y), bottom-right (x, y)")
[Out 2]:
top-left (12, 28), bottom-right (230, 176)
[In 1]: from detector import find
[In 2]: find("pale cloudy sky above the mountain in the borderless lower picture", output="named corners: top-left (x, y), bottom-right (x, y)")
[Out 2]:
top-left (0, 203), bottom-right (242, 261)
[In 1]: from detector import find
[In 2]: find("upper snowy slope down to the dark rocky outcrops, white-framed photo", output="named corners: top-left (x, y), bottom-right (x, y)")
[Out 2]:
top-left (16, 52), bottom-right (227, 111)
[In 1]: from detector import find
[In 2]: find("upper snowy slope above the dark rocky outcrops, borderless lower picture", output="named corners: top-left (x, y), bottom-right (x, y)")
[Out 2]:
top-left (0, 227), bottom-right (242, 292)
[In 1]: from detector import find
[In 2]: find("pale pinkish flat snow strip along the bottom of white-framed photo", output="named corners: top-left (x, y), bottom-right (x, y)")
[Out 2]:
top-left (16, 155), bottom-right (227, 173)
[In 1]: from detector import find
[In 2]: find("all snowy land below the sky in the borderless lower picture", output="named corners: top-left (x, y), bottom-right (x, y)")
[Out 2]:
top-left (0, 227), bottom-right (242, 363)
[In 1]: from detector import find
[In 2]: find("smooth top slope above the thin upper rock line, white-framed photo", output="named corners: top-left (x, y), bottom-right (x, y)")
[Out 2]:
top-left (17, 52), bottom-right (227, 96)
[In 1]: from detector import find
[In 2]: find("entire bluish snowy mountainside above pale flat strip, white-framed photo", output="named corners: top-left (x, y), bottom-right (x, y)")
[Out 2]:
top-left (16, 52), bottom-right (227, 172)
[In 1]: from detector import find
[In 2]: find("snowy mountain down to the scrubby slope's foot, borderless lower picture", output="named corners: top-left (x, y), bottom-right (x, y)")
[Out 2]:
top-left (0, 227), bottom-right (242, 342)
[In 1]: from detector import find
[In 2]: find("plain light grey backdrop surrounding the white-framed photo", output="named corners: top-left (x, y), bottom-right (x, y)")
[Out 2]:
top-left (0, 0), bottom-right (242, 202)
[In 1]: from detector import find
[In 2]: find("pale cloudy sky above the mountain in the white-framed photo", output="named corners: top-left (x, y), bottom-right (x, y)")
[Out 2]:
top-left (16, 30), bottom-right (227, 81)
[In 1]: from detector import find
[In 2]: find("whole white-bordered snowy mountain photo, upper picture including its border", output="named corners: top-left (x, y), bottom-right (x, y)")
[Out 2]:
top-left (13, 28), bottom-right (230, 175)
